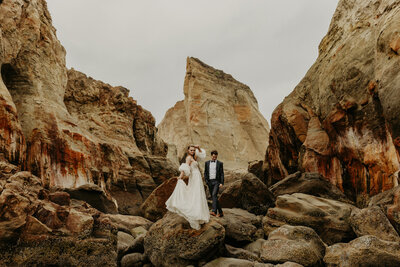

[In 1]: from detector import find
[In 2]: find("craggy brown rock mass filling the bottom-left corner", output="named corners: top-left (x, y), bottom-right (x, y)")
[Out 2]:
top-left (0, 165), bottom-right (117, 266)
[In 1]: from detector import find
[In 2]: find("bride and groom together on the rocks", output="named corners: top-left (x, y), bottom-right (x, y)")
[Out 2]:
top-left (165, 145), bottom-right (224, 230)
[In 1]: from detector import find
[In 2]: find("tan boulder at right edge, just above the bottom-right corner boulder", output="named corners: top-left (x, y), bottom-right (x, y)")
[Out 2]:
top-left (350, 206), bottom-right (400, 242)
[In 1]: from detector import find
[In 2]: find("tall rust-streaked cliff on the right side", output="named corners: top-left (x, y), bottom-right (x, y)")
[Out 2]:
top-left (265, 0), bottom-right (400, 206)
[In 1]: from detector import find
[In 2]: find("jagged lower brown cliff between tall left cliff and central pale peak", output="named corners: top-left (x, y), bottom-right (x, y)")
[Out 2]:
top-left (64, 70), bottom-right (178, 214)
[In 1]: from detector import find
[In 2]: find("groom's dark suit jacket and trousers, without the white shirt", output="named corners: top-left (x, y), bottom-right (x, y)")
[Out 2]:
top-left (204, 160), bottom-right (224, 214)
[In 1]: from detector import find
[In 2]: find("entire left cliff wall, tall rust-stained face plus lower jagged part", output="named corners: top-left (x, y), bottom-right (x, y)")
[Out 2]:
top-left (0, 0), bottom-right (176, 214)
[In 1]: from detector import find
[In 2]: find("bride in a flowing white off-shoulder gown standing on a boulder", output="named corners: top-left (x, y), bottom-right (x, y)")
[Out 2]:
top-left (165, 145), bottom-right (210, 230)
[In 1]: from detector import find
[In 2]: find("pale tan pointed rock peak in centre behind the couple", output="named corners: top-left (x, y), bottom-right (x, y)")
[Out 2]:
top-left (158, 58), bottom-right (269, 169)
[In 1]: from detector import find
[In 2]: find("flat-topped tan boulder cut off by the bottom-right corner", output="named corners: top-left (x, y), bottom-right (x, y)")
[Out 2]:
top-left (324, 235), bottom-right (400, 267)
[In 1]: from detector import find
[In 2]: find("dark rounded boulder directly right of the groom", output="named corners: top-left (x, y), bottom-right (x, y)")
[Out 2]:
top-left (219, 173), bottom-right (275, 215)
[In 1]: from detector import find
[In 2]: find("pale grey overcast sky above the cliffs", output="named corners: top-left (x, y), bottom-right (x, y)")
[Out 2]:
top-left (47, 0), bottom-right (338, 124)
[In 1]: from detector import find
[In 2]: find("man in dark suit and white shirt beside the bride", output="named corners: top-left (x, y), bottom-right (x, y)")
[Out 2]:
top-left (204, 150), bottom-right (224, 217)
